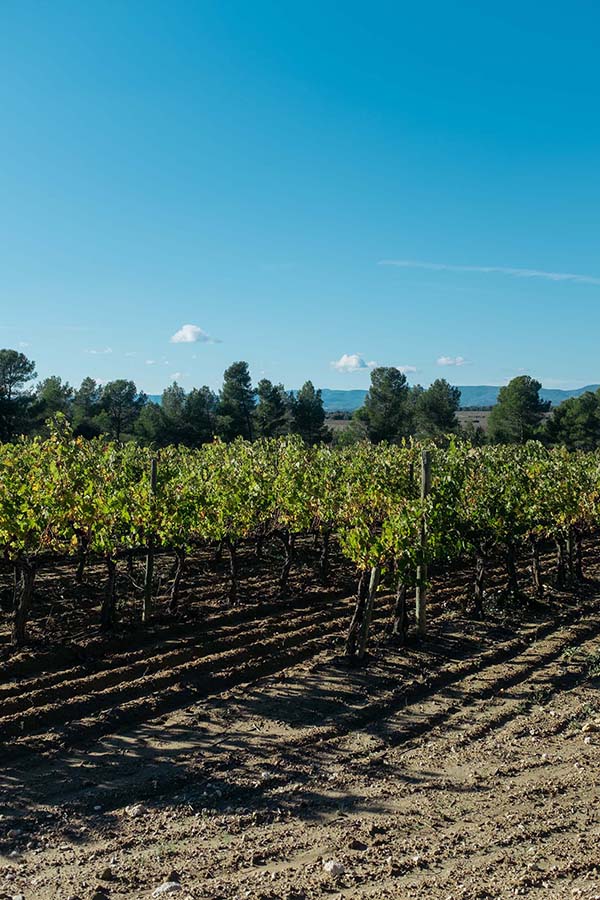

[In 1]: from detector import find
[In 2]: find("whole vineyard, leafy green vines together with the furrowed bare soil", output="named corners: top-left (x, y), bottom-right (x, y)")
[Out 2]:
top-left (0, 421), bottom-right (600, 900)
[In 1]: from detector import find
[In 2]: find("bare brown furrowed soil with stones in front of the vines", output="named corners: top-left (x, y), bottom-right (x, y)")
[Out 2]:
top-left (0, 544), bottom-right (600, 900)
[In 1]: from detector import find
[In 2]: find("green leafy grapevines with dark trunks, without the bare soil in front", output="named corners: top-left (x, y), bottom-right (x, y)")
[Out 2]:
top-left (0, 423), bottom-right (600, 655)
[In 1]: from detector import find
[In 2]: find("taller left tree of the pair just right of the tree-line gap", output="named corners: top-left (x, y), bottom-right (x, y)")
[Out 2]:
top-left (355, 366), bottom-right (414, 443)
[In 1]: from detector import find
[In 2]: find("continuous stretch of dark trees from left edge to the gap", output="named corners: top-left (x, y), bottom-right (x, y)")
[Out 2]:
top-left (0, 350), bottom-right (331, 447)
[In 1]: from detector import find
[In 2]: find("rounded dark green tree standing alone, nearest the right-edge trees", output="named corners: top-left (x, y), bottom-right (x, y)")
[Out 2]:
top-left (488, 375), bottom-right (551, 444)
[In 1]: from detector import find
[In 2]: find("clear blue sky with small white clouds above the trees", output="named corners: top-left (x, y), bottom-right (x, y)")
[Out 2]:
top-left (0, 0), bottom-right (600, 393)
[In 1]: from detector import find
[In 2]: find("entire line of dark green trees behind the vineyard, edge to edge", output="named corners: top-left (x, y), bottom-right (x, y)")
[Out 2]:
top-left (0, 349), bottom-right (600, 450)
